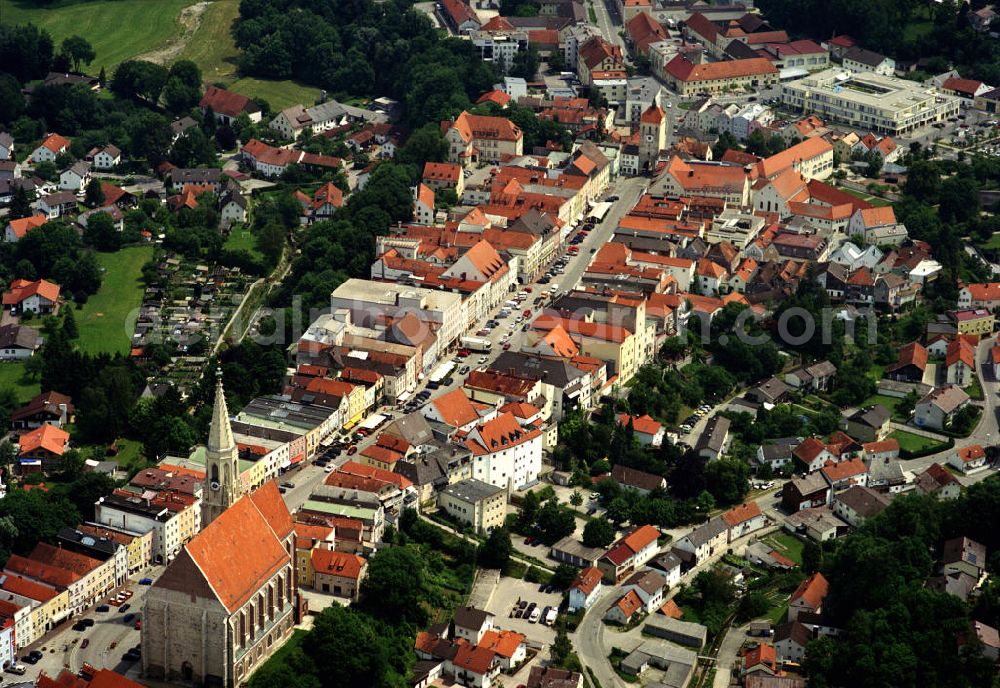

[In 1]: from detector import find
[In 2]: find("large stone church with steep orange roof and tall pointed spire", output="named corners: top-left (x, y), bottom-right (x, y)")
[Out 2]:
top-left (142, 375), bottom-right (300, 688)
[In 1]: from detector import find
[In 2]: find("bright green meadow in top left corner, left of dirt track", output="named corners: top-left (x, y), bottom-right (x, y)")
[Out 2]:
top-left (2, 0), bottom-right (194, 71)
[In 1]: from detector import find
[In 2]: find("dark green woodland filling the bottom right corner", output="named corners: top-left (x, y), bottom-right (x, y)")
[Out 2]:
top-left (805, 478), bottom-right (1000, 688)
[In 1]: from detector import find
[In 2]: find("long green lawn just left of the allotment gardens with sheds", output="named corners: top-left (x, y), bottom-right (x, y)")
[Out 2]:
top-left (74, 246), bottom-right (153, 353)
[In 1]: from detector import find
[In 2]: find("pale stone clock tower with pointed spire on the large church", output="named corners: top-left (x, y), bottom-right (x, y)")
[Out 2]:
top-left (201, 370), bottom-right (243, 528)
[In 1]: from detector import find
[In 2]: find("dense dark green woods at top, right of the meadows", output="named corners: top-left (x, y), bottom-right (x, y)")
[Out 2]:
top-left (234, 0), bottom-right (497, 129)
